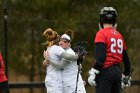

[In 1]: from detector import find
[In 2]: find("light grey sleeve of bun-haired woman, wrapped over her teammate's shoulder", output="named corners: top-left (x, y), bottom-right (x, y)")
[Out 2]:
top-left (60, 52), bottom-right (78, 61)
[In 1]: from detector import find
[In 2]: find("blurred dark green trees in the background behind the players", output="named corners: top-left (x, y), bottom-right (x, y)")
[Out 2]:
top-left (0, 0), bottom-right (140, 93)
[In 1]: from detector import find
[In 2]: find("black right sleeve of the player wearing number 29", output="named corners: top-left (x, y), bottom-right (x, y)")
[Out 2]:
top-left (123, 50), bottom-right (131, 76)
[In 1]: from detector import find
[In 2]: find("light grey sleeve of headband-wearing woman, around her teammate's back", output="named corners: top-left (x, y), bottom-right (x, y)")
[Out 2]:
top-left (49, 58), bottom-right (69, 69)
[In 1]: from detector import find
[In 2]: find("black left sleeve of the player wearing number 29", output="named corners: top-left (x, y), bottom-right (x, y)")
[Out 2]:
top-left (94, 42), bottom-right (106, 71)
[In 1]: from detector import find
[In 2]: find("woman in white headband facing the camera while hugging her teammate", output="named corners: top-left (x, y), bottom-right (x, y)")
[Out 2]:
top-left (45, 31), bottom-right (86, 93)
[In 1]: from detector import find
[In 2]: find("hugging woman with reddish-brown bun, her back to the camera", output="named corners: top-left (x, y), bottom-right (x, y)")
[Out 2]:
top-left (43, 28), bottom-right (78, 93)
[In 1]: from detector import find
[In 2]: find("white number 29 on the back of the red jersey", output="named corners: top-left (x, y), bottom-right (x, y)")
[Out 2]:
top-left (111, 38), bottom-right (123, 54)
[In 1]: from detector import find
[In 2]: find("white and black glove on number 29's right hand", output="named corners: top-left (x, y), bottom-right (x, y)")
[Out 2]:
top-left (121, 74), bottom-right (131, 89)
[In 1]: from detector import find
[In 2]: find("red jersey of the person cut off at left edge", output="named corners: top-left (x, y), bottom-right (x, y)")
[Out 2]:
top-left (0, 53), bottom-right (7, 82)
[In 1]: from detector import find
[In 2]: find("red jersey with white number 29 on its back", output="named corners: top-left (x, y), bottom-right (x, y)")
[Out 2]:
top-left (95, 28), bottom-right (126, 68)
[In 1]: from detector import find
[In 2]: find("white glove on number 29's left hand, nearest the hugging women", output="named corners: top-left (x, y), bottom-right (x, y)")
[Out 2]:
top-left (88, 68), bottom-right (99, 86)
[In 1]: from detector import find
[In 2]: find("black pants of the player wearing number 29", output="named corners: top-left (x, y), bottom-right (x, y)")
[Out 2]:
top-left (96, 65), bottom-right (122, 93)
